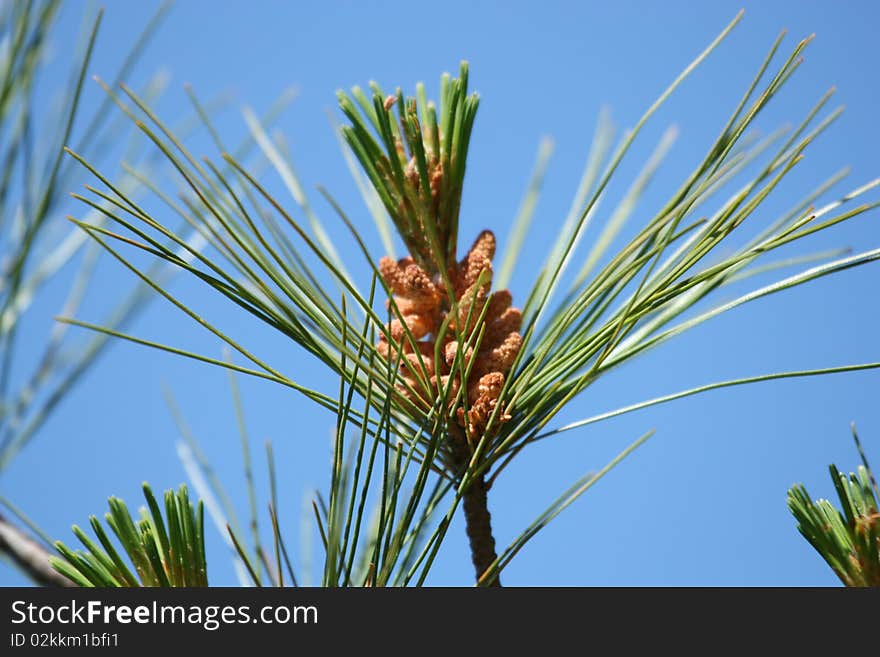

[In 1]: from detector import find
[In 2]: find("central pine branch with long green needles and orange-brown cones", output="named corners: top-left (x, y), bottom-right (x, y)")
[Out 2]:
top-left (60, 10), bottom-right (880, 586)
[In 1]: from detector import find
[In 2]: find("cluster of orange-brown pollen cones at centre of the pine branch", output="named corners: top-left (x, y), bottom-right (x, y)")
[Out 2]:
top-left (377, 230), bottom-right (522, 440)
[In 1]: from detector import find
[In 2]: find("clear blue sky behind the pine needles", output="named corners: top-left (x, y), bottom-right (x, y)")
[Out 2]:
top-left (0, 0), bottom-right (880, 586)
